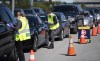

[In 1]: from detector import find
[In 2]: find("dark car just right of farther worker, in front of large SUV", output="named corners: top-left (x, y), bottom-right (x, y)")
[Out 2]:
top-left (53, 12), bottom-right (70, 40)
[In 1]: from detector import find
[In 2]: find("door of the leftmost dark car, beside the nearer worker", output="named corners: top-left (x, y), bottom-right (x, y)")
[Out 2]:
top-left (0, 9), bottom-right (13, 56)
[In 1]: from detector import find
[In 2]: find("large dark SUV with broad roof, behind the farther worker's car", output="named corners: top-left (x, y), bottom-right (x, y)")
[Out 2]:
top-left (52, 4), bottom-right (83, 33)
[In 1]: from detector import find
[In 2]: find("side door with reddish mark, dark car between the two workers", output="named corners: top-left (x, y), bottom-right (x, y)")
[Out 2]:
top-left (35, 17), bottom-right (46, 45)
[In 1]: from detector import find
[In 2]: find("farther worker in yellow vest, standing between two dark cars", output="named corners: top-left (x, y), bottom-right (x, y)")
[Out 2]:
top-left (47, 11), bottom-right (59, 49)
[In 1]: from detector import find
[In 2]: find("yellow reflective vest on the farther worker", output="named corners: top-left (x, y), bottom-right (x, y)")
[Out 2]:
top-left (48, 13), bottom-right (59, 30)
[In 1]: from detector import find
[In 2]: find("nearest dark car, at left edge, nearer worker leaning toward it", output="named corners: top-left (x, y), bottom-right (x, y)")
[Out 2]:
top-left (0, 4), bottom-right (17, 61)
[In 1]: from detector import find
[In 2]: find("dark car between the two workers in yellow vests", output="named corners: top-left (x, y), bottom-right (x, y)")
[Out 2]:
top-left (23, 15), bottom-right (49, 51)
